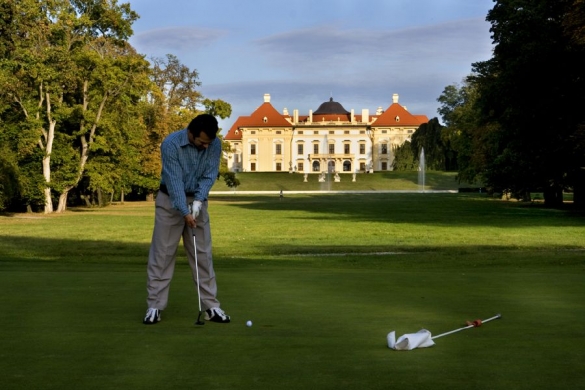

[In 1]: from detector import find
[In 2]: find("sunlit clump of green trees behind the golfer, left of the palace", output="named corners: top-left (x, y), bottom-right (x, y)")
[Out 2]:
top-left (0, 0), bottom-right (231, 213)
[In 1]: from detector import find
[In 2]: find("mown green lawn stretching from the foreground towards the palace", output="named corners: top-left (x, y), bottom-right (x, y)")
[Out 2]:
top-left (0, 194), bottom-right (585, 390)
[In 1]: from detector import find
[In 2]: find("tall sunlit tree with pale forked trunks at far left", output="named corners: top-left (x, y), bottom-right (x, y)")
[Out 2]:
top-left (0, 0), bottom-right (148, 212)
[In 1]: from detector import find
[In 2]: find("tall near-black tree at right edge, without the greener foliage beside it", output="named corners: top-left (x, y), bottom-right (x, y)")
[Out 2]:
top-left (471, 0), bottom-right (585, 206)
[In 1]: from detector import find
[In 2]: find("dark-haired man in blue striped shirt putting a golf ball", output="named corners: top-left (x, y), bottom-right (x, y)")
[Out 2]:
top-left (143, 114), bottom-right (230, 325)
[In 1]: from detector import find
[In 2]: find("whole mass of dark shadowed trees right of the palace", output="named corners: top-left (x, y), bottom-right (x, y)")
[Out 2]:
top-left (428, 0), bottom-right (585, 206)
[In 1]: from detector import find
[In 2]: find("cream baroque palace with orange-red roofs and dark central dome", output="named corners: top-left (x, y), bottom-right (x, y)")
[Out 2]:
top-left (224, 94), bottom-right (428, 173)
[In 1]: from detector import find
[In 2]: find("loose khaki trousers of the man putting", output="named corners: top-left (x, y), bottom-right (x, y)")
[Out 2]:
top-left (146, 192), bottom-right (219, 310)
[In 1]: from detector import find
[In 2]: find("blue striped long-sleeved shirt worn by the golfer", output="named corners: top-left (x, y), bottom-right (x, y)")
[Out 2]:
top-left (160, 129), bottom-right (221, 216)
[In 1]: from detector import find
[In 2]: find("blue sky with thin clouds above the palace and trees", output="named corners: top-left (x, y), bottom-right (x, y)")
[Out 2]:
top-left (128, 0), bottom-right (494, 133)
